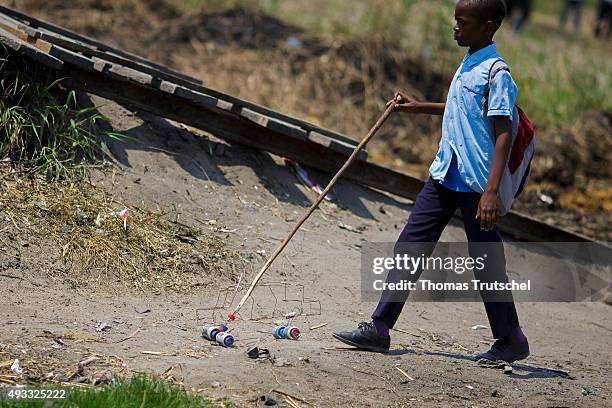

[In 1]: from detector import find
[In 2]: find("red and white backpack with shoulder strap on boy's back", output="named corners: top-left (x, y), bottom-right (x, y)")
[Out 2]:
top-left (484, 60), bottom-right (536, 215)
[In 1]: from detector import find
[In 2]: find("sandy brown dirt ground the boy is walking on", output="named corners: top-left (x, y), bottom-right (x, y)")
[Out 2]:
top-left (0, 99), bottom-right (612, 407)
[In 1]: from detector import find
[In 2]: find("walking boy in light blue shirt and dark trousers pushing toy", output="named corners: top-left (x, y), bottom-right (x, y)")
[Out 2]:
top-left (333, 0), bottom-right (529, 362)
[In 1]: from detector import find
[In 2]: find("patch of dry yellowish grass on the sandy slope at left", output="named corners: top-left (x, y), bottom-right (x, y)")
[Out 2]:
top-left (0, 168), bottom-right (239, 291)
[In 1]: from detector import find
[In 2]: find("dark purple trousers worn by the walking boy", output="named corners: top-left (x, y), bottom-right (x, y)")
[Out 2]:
top-left (372, 178), bottom-right (519, 339)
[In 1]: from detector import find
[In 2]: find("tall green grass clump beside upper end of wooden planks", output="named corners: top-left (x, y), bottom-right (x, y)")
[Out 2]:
top-left (0, 43), bottom-right (123, 180)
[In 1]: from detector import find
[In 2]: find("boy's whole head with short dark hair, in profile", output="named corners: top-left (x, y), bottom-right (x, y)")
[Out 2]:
top-left (453, 0), bottom-right (506, 48)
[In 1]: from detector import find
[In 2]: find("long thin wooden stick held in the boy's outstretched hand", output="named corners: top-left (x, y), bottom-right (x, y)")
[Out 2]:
top-left (233, 103), bottom-right (395, 315)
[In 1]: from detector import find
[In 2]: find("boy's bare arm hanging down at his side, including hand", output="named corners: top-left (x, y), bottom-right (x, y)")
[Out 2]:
top-left (476, 116), bottom-right (512, 231)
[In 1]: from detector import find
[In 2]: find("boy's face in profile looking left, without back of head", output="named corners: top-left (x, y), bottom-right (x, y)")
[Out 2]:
top-left (453, 0), bottom-right (495, 47)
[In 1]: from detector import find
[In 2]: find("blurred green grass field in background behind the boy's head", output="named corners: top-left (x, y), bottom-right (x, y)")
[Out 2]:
top-left (174, 0), bottom-right (612, 130)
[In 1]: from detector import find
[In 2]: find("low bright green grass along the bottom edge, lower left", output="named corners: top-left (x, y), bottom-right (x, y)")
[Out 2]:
top-left (0, 376), bottom-right (233, 408)
